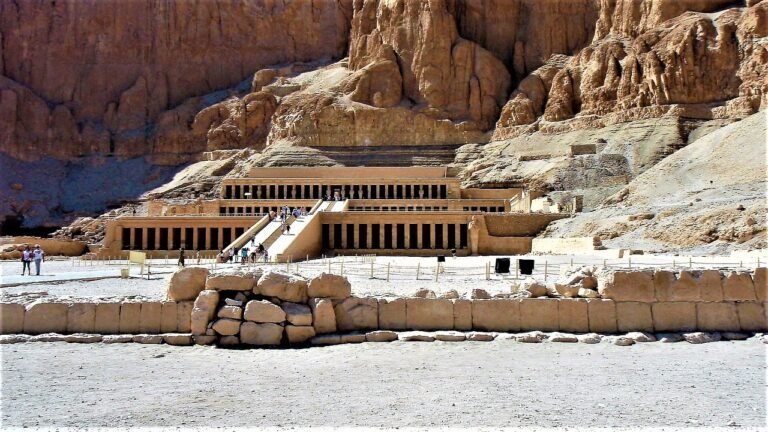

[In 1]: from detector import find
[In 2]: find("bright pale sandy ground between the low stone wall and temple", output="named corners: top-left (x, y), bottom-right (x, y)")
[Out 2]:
top-left (0, 251), bottom-right (768, 301)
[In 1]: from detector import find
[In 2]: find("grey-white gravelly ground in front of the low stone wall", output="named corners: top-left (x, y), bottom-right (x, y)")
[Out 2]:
top-left (0, 341), bottom-right (766, 428)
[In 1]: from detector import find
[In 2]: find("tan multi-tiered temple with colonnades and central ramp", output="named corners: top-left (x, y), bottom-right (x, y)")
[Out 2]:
top-left (100, 167), bottom-right (569, 262)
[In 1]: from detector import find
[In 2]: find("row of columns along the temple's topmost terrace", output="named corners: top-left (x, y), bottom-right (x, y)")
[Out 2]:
top-left (224, 184), bottom-right (448, 199)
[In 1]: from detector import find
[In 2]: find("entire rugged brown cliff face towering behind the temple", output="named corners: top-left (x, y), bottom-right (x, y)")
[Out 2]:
top-left (0, 0), bottom-right (768, 248)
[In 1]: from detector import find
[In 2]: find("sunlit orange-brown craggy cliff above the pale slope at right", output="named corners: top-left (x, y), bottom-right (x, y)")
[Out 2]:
top-left (494, 1), bottom-right (768, 139)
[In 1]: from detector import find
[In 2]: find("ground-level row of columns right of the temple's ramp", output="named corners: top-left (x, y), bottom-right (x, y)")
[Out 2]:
top-left (322, 223), bottom-right (468, 250)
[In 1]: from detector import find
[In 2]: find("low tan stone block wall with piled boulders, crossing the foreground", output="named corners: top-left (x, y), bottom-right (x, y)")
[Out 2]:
top-left (0, 268), bottom-right (768, 345)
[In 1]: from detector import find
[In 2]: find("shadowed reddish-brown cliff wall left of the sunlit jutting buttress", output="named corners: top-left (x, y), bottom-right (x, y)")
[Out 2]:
top-left (0, 0), bottom-right (351, 163)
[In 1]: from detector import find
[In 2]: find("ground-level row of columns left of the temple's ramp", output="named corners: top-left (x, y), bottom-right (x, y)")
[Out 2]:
top-left (119, 227), bottom-right (245, 250)
